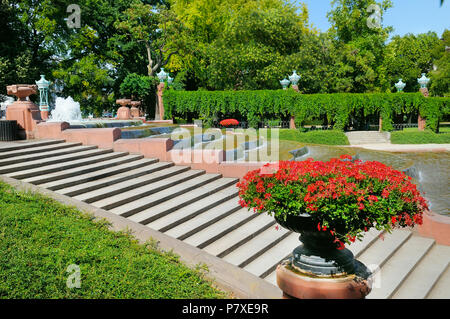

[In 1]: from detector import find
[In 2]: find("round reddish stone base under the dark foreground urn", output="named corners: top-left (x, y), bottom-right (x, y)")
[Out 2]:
top-left (276, 259), bottom-right (371, 299)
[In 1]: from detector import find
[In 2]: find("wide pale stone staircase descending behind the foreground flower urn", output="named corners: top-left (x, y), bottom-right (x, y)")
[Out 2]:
top-left (0, 140), bottom-right (450, 298)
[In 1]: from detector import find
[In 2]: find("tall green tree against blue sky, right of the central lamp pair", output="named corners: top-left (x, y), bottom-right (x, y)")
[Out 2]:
top-left (327, 0), bottom-right (392, 92)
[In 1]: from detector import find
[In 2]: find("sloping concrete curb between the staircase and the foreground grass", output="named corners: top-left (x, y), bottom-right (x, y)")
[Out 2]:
top-left (0, 176), bottom-right (282, 299)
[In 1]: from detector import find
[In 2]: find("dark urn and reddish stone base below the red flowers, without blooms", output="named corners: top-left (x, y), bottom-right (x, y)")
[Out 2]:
top-left (275, 214), bottom-right (370, 299)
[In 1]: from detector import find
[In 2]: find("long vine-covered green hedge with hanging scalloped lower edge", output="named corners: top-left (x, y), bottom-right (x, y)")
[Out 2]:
top-left (163, 89), bottom-right (450, 131)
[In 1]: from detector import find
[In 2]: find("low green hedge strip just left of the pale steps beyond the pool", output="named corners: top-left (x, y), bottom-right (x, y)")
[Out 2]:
top-left (280, 129), bottom-right (349, 145)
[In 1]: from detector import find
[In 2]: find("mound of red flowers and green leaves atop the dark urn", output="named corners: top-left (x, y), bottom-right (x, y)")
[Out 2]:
top-left (237, 155), bottom-right (428, 248)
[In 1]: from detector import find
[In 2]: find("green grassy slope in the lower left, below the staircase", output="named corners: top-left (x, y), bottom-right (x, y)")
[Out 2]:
top-left (0, 183), bottom-right (228, 299)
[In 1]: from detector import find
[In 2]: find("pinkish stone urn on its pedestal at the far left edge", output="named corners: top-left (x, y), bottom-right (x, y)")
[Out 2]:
top-left (6, 84), bottom-right (42, 139)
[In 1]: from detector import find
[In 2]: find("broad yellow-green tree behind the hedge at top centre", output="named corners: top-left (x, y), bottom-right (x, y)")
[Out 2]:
top-left (170, 0), bottom-right (309, 89)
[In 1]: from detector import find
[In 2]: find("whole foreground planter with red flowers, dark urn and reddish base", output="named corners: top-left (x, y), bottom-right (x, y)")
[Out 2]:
top-left (238, 155), bottom-right (428, 298)
